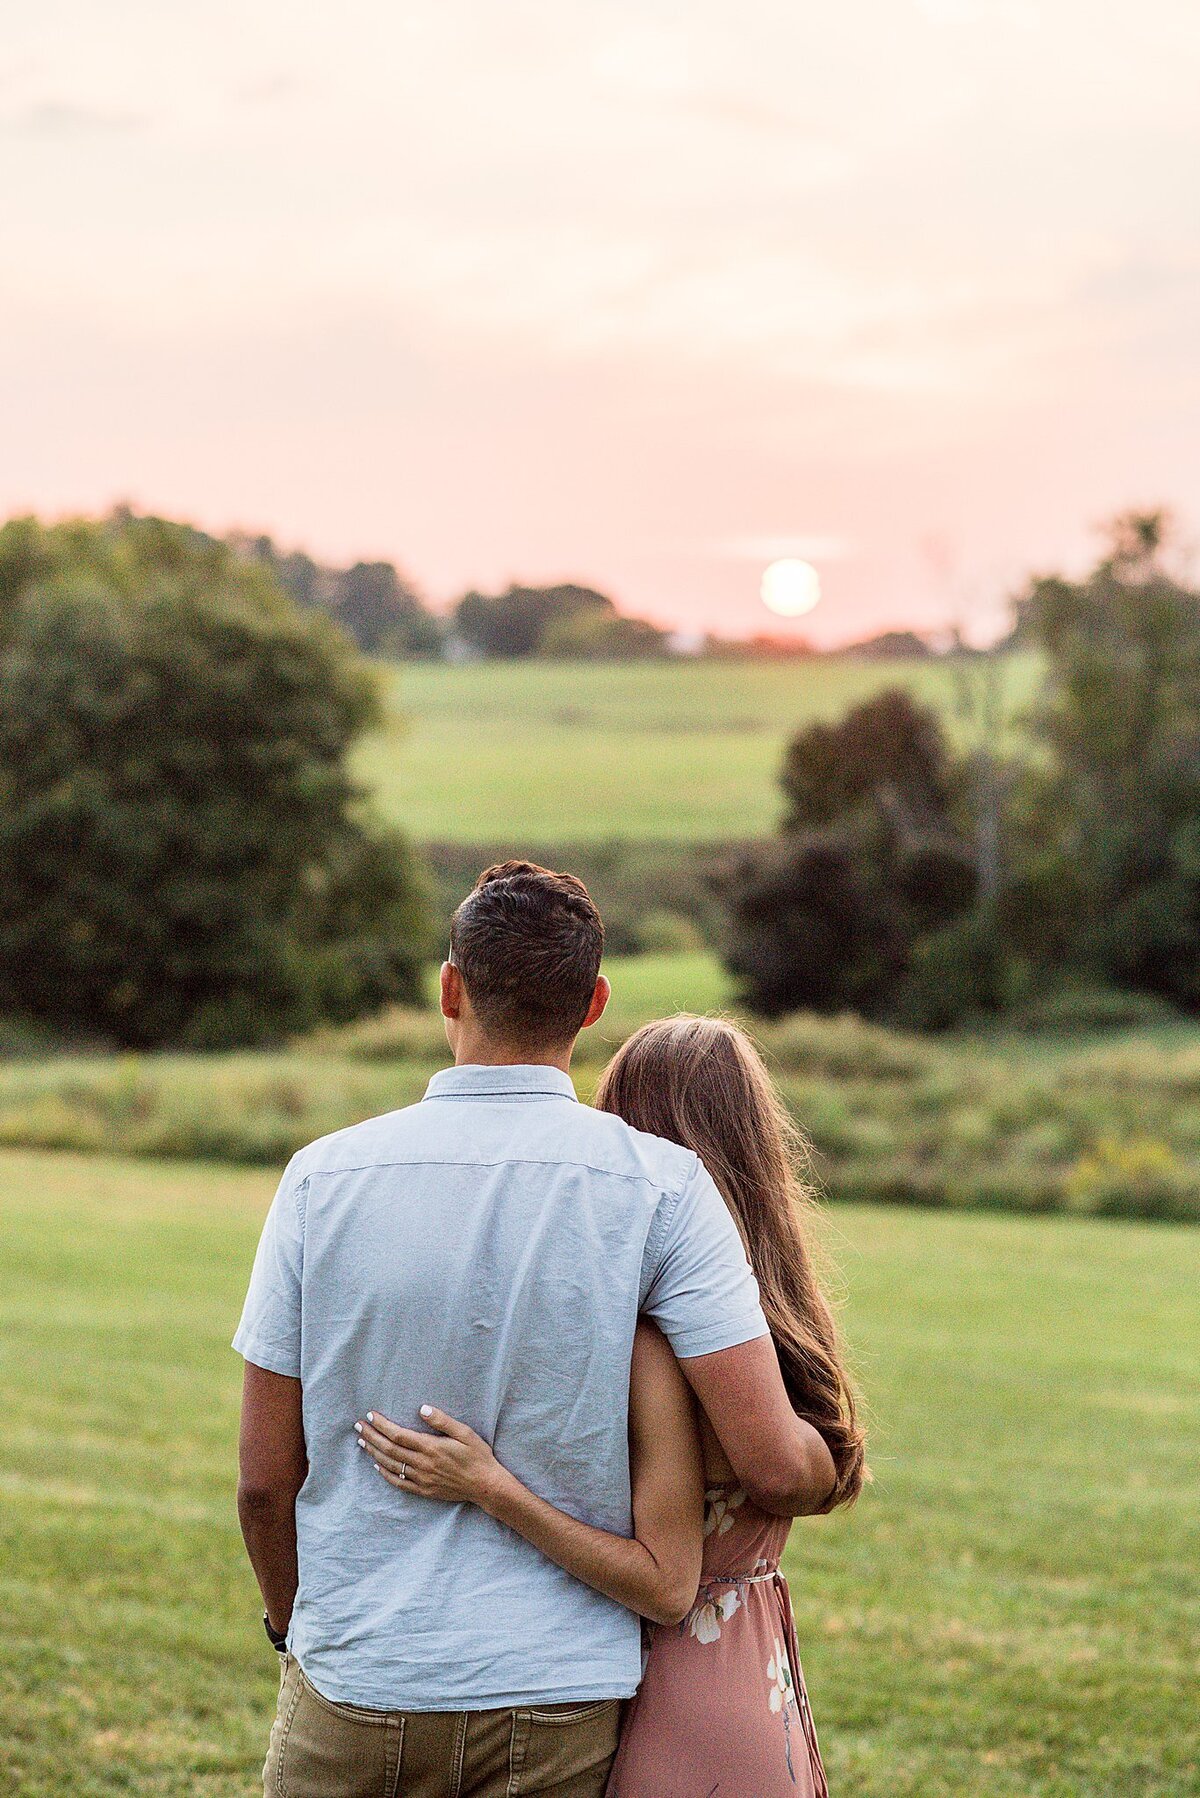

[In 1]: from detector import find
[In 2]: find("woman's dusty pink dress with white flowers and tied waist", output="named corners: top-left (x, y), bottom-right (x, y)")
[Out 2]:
top-left (608, 1483), bottom-right (829, 1798)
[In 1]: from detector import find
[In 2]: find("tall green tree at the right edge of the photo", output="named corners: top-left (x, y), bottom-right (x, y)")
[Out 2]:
top-left (1006, 512), bottom-right (1200, 1010)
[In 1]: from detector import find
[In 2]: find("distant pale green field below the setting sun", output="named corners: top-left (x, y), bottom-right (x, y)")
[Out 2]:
top-left (358, 656), bottom-right (1034, 843)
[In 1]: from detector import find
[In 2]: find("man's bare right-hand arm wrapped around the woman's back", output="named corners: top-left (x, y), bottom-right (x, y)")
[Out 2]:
top-left (680, 1336), bottom-right (837, 1518)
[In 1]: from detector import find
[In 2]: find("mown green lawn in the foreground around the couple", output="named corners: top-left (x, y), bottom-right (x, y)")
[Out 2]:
top-left (0, 1151), bottom-right (1200, 1798)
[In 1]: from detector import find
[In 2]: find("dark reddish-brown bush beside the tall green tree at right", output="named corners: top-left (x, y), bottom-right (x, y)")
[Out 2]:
top-left (721, 690), bottom-right (1000, 1028)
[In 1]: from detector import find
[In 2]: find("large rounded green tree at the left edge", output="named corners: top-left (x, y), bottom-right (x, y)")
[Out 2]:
top-left (0, 514), bottom-right (425, 1046)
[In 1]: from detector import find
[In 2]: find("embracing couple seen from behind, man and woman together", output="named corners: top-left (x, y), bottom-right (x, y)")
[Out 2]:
top-left (234, 861), bottom-right (864, 1798)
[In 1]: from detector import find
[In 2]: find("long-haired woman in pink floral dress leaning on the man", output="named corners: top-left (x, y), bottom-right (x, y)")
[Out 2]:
top-left (356, 1018), bottom-right (865, 1798)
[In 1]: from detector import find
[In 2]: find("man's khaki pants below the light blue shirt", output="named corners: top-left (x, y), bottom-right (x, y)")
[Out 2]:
top-left (263, 1656), bottom-right (621, 1798)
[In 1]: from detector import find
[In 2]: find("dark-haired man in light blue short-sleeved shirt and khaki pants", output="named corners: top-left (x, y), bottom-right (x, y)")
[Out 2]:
top-left (234, 861), bottom-right (833, 1798)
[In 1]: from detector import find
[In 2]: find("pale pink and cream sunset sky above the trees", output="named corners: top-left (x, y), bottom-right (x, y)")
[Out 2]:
top-left (0, 0), bottom-right (1200, 644)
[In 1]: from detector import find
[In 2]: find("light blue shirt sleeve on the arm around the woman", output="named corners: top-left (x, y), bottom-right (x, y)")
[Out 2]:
top-left (642, 1162), bottom-right (768, 1356)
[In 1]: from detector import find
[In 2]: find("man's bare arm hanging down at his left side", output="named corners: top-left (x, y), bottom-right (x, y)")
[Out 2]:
top-left (237, 1356), bottom-right (307, 1634)
